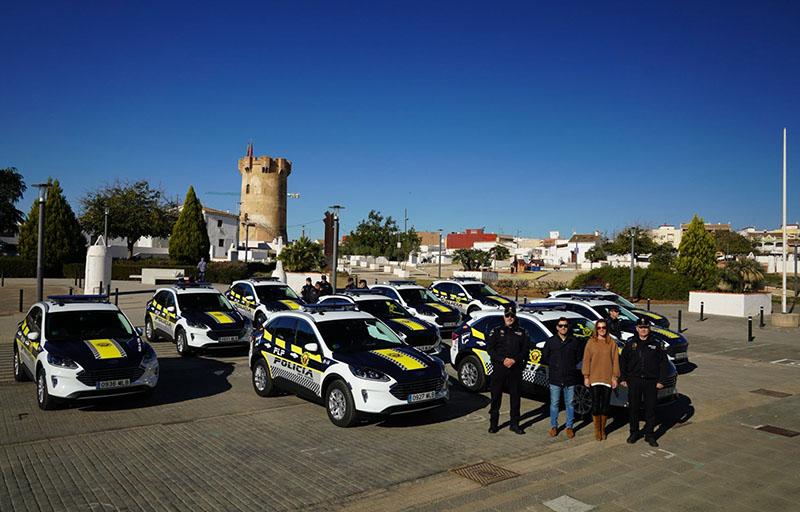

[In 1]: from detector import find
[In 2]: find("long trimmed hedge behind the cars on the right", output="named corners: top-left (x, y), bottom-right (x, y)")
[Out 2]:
top-left (571, 267), bottom-right (697, 300)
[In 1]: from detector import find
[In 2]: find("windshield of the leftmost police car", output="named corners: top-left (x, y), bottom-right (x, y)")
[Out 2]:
top-left (44, 310), bottom-right (134, 342)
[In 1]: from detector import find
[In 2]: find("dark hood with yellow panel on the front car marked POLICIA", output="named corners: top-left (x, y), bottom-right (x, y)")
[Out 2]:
top-left (334, 346), bottom-right (441, 382)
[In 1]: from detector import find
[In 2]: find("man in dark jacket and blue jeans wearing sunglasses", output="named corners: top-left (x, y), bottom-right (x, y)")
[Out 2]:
top-left (541, 317), bottom-right (583, 439)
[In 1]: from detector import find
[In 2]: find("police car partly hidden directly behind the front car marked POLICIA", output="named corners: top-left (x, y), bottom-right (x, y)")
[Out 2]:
top-left (318, 290), bottom-right (442, 355)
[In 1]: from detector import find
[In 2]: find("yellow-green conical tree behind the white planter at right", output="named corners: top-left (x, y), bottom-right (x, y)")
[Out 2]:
top-left (675, 215), bottom-right (718, 290)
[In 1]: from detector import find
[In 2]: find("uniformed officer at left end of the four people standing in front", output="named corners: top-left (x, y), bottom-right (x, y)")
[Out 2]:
top-left (486, 304), bottom-right (529, 434)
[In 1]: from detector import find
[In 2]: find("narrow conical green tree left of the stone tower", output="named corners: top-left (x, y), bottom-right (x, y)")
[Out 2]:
top-left (169, 186), bottom-right (211, 263)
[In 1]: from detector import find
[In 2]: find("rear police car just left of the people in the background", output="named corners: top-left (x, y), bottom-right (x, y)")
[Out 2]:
top-left (225, 277), bottom-right (304, 325)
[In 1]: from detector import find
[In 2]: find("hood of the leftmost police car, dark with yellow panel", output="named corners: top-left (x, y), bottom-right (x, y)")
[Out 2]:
top-left (45, 336), bottom-right (145, 370)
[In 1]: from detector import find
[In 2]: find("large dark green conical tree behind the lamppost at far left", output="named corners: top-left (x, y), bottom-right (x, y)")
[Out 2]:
top-left (19, 179), bottom-right (86, 271)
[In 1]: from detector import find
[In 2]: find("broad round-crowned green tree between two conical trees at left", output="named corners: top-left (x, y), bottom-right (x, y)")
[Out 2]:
top-left (80, 180), bottom-right (177, 258)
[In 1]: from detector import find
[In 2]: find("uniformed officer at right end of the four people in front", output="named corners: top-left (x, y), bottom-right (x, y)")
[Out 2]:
top-left (619, 318), bottom-right (668, 447)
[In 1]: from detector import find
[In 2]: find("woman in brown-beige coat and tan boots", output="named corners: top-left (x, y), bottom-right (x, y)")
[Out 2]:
top-left (582, 320), bottom-right (619, 441)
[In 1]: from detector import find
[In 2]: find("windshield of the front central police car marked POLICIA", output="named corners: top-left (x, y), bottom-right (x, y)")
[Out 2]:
top-left (317, 318), bottom-right (403, 353)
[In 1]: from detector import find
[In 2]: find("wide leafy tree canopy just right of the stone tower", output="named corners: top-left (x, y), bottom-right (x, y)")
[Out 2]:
top-left (341, 210), bottom-right (420, 259)
